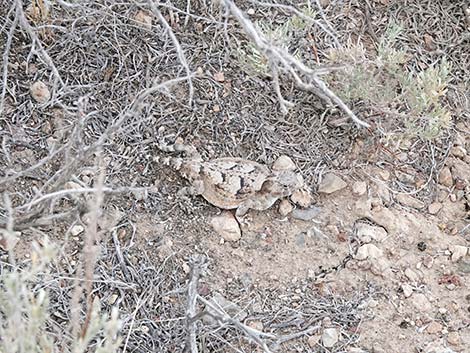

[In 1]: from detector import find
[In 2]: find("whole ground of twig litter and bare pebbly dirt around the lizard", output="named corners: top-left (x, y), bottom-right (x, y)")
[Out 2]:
top-left (0, 0), bottom-right (470, 353)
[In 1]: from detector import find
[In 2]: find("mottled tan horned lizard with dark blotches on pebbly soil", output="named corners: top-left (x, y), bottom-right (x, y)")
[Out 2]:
top-left (158, 139), bottom-right (311, 216)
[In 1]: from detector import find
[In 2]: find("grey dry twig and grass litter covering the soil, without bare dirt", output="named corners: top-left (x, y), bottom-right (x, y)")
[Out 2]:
top-left (0, 0), bottom-right (470, 352)
